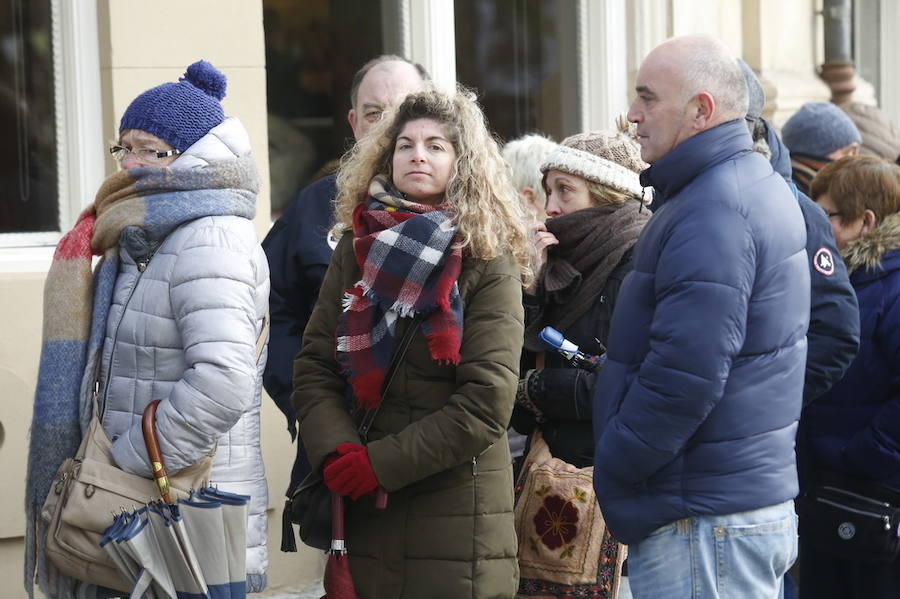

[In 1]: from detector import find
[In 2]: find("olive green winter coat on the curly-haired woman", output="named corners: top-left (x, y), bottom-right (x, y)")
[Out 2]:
top-left (292, 234), bottom-right (523, 599)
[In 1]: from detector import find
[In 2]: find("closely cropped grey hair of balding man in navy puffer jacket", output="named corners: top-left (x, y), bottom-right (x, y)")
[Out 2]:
top-left (674, 35), bottom-right (749, 120)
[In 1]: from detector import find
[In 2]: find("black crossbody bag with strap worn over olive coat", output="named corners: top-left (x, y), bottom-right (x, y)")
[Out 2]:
top-left (281, 316), bottom-right (422, 552)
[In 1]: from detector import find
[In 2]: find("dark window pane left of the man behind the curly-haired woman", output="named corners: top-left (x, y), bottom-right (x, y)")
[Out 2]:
top-left (263, 0), bottom-right (383, 216)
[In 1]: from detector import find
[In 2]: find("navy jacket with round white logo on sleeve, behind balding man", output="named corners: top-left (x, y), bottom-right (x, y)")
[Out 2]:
top-left (766, 123), bottom-right (859, 404)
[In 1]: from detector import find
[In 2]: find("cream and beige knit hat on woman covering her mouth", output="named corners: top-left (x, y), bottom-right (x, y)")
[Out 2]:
top-left (541, 131), bottom-right (650, 197)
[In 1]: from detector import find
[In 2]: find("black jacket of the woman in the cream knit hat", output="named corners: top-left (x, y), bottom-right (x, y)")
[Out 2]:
top-left (512, 251), bottom-right (631, 468)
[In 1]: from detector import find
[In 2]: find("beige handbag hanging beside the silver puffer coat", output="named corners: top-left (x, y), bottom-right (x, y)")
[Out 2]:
top-left (41, 318), bottom-right (269, 591)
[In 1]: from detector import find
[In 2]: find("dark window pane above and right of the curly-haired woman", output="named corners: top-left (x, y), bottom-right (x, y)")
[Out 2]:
top-left (454, 0), bottom-right (577, 140)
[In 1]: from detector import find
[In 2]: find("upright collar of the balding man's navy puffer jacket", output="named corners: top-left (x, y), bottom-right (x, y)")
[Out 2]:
top-left (641, 119), bottom-right (753, 202)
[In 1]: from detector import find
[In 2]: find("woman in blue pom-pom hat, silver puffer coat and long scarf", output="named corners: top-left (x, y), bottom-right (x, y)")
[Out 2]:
top-left (25, 60), bottom-right (269, 599)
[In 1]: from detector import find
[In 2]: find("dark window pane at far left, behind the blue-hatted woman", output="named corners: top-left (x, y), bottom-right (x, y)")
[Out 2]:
top-left (0, 0), bottom-right (59, 233)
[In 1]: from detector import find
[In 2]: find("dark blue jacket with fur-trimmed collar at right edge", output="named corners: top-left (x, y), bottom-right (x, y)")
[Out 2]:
top-left (803, 213), bottom-right (900, 489)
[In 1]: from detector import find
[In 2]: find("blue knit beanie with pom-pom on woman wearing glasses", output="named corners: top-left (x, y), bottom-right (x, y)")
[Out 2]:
top-left (119, 60), bottom-right (228, 152)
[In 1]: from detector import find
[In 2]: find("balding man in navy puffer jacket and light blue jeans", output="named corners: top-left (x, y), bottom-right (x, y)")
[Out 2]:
top-left (594, 36), bottom-right (810, 598)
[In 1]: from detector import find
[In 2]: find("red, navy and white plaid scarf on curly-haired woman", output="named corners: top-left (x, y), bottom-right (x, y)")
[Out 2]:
top-left (337, 176), bottom-right (463, 410)
